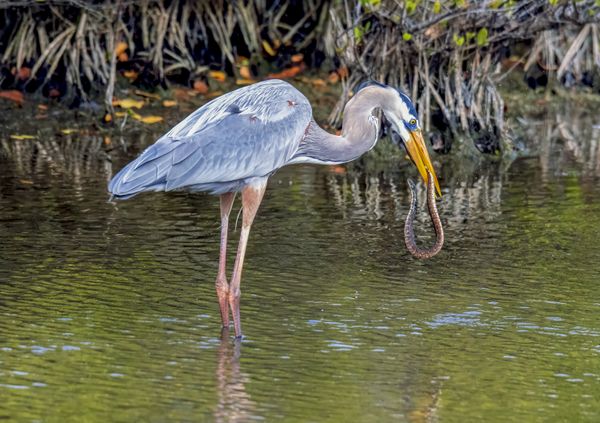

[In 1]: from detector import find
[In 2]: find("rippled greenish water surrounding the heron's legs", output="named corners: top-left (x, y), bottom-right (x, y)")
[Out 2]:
top-left (0, 103), bottom-right (600, 422)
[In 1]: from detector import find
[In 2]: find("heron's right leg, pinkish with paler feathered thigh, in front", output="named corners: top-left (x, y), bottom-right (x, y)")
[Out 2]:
top-left (229, 179), bottom-right (267, 338)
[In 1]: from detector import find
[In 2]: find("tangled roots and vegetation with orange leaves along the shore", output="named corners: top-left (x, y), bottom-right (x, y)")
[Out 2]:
top-left (0, 0), bottom-right (600, 152)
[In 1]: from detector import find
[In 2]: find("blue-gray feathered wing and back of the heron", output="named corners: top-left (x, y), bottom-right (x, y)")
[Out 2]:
top-left (109, 80), bottom-right (312, 197)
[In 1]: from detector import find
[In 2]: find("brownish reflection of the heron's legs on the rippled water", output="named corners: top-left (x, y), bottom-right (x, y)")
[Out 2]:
top-left (214, 328), bottom-right (254, 422)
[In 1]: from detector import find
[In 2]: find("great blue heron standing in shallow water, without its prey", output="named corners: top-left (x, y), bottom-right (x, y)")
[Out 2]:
top-left (108, 79), bottom-right (440, 337)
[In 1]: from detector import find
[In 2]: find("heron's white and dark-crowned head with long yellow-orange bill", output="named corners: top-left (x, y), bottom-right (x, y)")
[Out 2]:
top-left (358, 81), bottom-right (442, 196)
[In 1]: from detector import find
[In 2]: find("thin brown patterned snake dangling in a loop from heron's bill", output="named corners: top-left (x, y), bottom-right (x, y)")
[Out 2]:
top-left (404, 171), bottom-right (444, 259)
